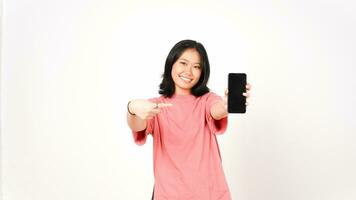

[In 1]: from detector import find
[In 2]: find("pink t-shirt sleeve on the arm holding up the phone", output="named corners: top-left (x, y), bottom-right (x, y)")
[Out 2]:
top-left (205, 92), bottom-right (227, 135)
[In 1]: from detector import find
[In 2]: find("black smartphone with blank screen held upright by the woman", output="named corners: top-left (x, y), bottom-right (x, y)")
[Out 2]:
top-left (227, 73), bottom-right (247, 113)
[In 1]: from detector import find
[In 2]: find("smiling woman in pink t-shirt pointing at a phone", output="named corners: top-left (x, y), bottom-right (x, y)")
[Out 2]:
top-left (127, 40), bottom-right (250, 200)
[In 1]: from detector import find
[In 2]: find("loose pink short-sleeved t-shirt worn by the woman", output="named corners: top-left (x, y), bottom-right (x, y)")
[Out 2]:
top-left (133, 92), bottom-right (231, 200)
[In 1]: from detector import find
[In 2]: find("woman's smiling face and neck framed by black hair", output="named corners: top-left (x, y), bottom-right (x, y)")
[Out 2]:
top-left (172, 49), bottom-right (202, 95)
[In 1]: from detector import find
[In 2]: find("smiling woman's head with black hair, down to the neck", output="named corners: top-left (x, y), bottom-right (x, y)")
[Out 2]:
top-left (159, 40), bottom-right (210, 97)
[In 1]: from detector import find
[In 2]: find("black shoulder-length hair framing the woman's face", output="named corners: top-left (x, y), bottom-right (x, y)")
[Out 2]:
top-left (159, 40), bottom-right (210, 97)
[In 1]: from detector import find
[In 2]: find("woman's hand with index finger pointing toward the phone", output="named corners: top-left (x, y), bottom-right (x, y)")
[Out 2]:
top-left (128, 99), bottom-right (172, 120)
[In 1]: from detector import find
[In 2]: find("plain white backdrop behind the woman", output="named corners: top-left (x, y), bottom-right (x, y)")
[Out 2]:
top-left (1, 0), bottom-right (356, 200)
